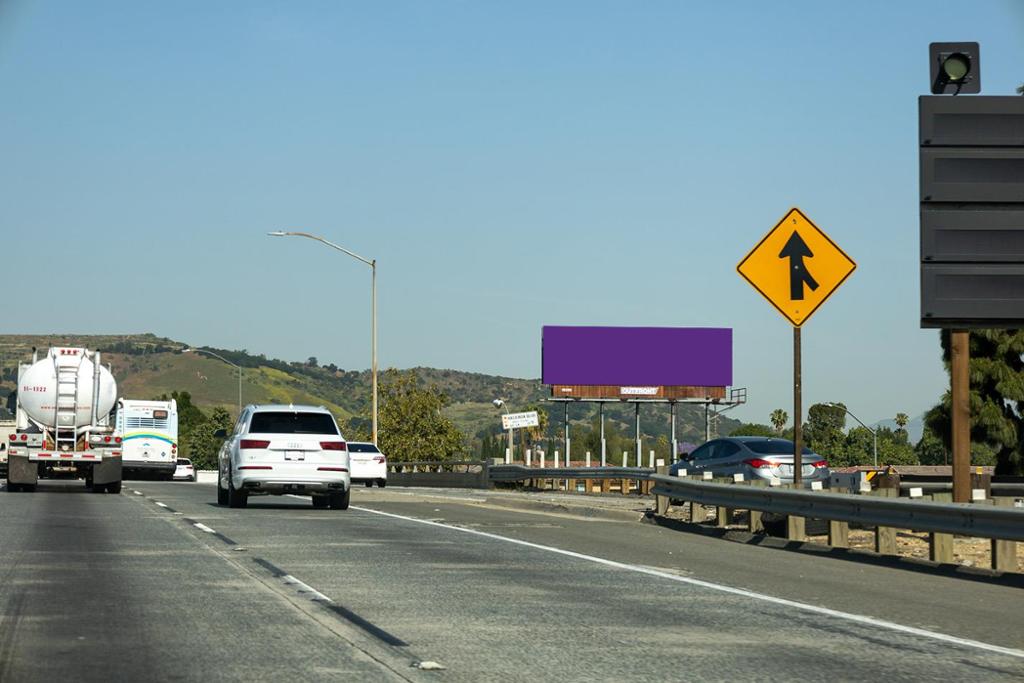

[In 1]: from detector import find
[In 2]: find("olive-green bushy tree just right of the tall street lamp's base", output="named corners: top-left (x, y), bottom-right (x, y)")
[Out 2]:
top-left (377, 369), bottom-right (465, 461)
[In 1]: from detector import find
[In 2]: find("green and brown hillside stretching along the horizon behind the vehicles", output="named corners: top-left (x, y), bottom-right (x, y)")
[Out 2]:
top-left (0, 334), bottom-right (739, 454)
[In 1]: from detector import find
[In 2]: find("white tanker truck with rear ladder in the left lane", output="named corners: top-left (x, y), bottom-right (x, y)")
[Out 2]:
top-left (7, 346), bottom-right (121, 494)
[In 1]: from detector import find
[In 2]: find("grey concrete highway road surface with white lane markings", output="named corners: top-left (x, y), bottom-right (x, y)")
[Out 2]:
top-left (0, 481), bottom-right (1024, 681)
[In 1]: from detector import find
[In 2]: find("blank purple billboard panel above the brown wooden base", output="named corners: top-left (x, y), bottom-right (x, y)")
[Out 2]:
top-left (541, 326), bottom-right (732, 387)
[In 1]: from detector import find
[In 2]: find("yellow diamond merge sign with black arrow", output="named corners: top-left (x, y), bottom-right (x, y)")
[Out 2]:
top-left (736, 208), bottom-right (857, 328)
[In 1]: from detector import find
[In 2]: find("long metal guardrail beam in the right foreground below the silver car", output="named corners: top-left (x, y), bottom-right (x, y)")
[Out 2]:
top-left (649, 474), bottom-right (1024, 541)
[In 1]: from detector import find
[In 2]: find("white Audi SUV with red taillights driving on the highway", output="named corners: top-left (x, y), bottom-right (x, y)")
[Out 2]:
top-left (217, 404), bottom-right (351, 510)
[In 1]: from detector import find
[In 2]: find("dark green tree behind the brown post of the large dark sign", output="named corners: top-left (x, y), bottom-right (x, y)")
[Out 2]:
top-left (925, 330), bottom-right (1024, 474)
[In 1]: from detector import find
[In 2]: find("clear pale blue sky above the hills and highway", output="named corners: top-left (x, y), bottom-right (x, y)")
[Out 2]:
top-left (0, 0), bottom-right (1024, 422)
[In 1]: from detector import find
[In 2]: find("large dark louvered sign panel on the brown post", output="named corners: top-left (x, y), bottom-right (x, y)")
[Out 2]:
top-left (919, 95), bottom-right (1024, 329)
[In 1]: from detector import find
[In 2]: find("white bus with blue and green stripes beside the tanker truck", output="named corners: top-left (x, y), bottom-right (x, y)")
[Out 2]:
top-left (115, 398), bottom-right (178, 481)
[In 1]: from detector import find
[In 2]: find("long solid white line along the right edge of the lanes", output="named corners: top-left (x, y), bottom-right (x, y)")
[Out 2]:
top-left (352, 505), bottom-right (1024, 658)
